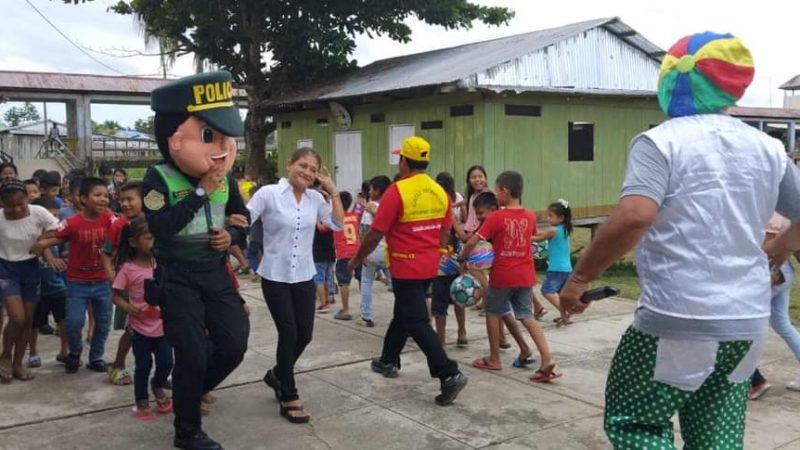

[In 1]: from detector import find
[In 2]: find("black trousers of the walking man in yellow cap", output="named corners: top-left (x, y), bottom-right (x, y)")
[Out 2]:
top-left (381, 278), bottom-right (459, 379)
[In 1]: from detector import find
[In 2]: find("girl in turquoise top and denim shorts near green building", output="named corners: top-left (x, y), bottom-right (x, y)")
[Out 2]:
top-left (533, 199), bottom-right (572, 327)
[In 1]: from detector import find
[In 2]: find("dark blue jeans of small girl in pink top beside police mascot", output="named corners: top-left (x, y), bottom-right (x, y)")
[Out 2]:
top-left (128, 330), bottom-right (172, 403)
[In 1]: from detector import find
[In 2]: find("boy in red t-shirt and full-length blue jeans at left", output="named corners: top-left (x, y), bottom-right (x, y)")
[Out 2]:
top-left (37, 177), bottom-right (116, 373)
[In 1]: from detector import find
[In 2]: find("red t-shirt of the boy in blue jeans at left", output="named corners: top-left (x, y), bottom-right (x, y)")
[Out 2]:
top-left (55, 212), bottom-right (117, 281)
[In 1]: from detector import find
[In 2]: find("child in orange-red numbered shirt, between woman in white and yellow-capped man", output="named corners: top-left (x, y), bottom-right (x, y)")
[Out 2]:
top-left (333, 191), bottom-right (361, 320)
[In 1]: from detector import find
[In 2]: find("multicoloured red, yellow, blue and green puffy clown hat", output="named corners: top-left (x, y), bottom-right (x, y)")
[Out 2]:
top-left (658, 31), bottom-right (755, 117)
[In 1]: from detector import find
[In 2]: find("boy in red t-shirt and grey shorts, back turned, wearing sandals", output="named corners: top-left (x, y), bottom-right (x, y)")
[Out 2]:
top-left (461, 171), bottom-right (560, 383)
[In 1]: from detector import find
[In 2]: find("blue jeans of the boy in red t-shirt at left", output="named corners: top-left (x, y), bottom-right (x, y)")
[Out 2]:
top-left (66, 281), bottom-right (111, 362)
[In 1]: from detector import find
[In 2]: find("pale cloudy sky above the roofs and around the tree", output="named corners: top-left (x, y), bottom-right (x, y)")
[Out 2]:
top-left (0, 0), bottom-right (800, 127)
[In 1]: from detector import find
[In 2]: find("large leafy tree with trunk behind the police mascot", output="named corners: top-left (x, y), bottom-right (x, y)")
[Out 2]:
top-left (63, 0), bottom-right (513, 177)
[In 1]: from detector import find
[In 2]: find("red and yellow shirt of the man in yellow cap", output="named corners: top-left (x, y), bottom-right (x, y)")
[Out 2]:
top-left (372, 173), bottom-right (453, 280)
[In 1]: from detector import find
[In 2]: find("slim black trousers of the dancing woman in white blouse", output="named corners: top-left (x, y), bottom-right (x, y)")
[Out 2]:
top-left (261, 278), bottom-right (317, 402)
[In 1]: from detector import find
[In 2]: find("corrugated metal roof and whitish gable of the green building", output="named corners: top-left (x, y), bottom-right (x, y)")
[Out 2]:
top-left (267, 17), bottom-right (664, 106)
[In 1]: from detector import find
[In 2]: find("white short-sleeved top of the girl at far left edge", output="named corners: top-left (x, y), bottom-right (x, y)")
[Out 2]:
top-left (0, 205), bottom-right (58, 261)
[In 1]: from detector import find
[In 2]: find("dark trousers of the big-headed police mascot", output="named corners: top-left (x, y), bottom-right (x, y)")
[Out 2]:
top-left (156, 260), bottom-right (250, 434)
